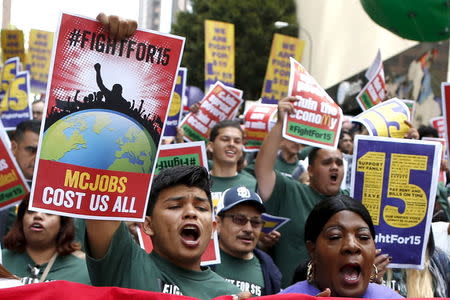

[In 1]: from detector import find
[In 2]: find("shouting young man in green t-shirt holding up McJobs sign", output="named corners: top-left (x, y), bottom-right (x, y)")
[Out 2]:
top-left (85, 166), bottom-right (244, 300)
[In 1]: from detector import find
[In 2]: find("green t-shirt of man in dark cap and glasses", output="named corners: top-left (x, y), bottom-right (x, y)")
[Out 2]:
top-left (214, 250), bottom-right (264, 296)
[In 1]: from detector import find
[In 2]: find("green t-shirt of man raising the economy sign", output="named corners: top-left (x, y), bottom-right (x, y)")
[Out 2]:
top-left (264, 172), bottom-right (344, 288)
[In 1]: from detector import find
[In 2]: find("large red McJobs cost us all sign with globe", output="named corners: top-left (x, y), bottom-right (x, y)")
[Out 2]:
top-left (30, 14), bottom-right (184, 221)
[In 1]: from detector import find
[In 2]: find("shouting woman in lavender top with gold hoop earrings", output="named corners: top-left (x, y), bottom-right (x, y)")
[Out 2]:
top-left (281, 195), bottom-right (403, 299)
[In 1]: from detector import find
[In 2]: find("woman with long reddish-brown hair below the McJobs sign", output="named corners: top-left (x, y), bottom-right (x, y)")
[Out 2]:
top-left (2, 196), bottom-right (90, 284)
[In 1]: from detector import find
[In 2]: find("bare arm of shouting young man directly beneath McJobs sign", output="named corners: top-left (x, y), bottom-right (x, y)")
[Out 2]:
top-left (86, 220), bottom-right (120, 259)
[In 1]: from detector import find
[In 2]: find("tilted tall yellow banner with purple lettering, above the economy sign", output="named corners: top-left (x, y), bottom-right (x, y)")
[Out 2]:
top-left (261, 33), bottom-right (305, 104)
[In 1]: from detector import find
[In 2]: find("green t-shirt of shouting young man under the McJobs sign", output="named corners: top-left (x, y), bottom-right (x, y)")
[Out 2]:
top-left (85, 223), bottom-right (240, 300)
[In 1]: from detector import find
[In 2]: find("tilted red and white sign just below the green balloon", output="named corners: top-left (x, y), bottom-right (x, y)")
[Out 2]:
top-left (356, 50), bottom-right (386, 111)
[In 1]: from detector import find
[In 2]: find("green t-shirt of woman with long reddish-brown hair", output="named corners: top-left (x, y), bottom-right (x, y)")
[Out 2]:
top-left (2, 249), bottom-right (91, 284)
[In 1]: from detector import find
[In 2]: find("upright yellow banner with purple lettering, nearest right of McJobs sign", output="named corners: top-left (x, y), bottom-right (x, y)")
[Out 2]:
top-left (205, 20), bottom-right (235, 91)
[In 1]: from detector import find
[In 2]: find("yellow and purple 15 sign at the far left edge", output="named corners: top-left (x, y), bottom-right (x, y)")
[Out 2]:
top-left (0, 57), bottom-right (31, 130)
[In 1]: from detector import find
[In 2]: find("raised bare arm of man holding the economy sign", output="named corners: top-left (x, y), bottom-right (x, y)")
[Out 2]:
top-left (255, 97), bottom-right (296, 201)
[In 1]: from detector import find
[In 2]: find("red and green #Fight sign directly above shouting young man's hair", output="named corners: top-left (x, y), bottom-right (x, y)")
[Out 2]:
top-left (155, 141), bottom-right (208, 175)
